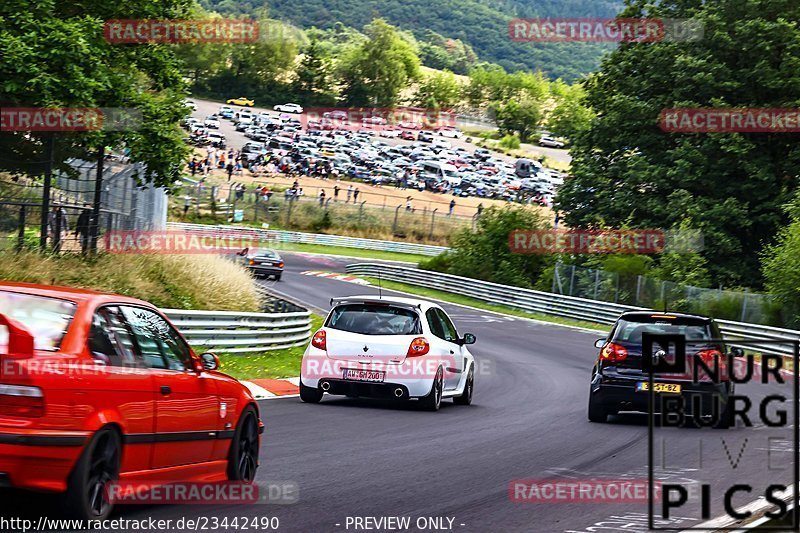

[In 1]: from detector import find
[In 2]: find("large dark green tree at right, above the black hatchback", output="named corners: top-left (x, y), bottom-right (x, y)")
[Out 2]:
top-left (556, 0), bottom-right (800, 286)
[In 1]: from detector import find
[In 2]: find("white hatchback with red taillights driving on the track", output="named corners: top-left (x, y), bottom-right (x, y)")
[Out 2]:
top-left (300, 295), bottom-right (475, 411)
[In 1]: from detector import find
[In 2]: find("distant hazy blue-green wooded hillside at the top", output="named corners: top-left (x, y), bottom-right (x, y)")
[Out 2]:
top-left (201, 0), bottom-right (622, 81)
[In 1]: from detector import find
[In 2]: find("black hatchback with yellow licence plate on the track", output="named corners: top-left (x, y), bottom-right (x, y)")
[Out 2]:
top-left (588, 312), bottom-right (742, 428)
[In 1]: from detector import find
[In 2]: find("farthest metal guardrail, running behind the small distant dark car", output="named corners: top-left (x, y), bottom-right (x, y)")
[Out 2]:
top-left (167, 222), bottom-right (448, 256)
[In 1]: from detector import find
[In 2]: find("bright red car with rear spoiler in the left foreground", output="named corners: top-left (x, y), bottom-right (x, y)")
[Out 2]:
top-left (0, 282), bottom-right (264, 519)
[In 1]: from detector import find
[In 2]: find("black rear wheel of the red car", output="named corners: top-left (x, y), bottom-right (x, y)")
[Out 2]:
top-left (65, 428), bottom-right (122, 520)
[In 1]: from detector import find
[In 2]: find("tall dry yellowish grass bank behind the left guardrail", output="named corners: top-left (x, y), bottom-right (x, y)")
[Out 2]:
top-left (0, 252), bottom-right (260, 311)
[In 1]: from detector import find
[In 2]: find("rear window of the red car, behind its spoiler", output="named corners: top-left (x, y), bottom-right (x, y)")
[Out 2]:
top-left (0, 290), bottom-right (77, 353)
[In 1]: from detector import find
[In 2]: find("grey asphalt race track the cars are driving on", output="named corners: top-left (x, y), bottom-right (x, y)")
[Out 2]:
top-left (4, 253), bottom-right (791, 532)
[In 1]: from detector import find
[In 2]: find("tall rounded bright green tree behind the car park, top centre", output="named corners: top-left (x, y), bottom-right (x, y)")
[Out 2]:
top-left (339, 19), bottom-right (419, 107)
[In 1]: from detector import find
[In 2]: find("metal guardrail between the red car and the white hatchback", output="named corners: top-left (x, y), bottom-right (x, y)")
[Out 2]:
top-left (163, 309), bottom-right (311, 353)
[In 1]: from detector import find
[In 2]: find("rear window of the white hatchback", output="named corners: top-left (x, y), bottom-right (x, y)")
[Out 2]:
top-left (325, 304), bottom-right (422, 335)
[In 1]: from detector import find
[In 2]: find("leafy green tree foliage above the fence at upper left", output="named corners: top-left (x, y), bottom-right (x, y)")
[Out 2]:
top-left (0, 0), bottom-right (191, 186)
